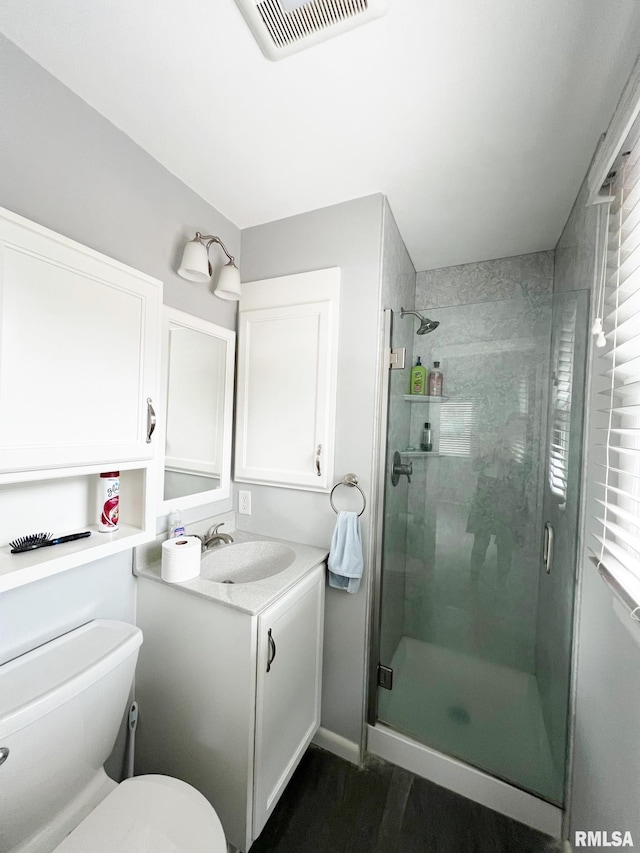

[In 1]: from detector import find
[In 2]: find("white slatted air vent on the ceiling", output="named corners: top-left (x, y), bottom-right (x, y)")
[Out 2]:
top-left (236, 0), bottom-right (391, 59)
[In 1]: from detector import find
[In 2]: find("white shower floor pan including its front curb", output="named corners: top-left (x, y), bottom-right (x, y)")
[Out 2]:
top-left (368, 637), bottom-right (562, 835)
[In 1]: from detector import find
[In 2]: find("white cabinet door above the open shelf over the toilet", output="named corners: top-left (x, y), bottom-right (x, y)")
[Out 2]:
top-left (0, 209), bottom-right (162, 471)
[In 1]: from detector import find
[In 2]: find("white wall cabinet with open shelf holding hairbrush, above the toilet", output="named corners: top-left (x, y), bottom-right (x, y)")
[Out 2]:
top-left (0, 208), bottom-right (162, 591)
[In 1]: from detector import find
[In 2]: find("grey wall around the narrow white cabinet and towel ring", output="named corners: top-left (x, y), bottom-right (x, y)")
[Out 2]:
top-left (240, 195), bottom-right (383, 744)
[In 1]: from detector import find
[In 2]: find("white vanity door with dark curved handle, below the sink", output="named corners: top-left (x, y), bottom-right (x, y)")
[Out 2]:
top-left (253, 566), bottom-right (324, 839)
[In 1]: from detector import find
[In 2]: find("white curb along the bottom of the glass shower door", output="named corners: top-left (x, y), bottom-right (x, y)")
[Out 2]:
top-left (367, 724), bottom-right (562, 838)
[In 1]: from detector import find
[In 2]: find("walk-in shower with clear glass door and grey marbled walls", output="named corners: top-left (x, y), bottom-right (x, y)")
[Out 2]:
top-left (369, 288), bottom-right (588, 832)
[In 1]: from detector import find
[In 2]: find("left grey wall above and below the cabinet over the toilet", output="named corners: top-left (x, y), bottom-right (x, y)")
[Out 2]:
top-left (0, 36), bottom-right (240, 772)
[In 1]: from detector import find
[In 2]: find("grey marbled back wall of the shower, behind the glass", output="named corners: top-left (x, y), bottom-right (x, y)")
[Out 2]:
top-left (404, 252), bottom-right (554, 672)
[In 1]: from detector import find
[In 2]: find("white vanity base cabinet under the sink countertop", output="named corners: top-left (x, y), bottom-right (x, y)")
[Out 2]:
top-left (136, 565), bottom-right (325, 851)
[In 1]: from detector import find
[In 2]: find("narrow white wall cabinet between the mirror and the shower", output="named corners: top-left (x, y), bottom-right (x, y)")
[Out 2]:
top-left (235, 268), bottom-right (340, 491)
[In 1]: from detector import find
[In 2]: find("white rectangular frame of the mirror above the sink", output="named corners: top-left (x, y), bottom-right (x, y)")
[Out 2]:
top-left (158, 305), bottom-right (236, 515)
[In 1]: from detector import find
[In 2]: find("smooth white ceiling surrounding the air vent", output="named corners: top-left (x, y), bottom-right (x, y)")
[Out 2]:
top-left (0, 0), bottom-right (640, 270)
